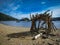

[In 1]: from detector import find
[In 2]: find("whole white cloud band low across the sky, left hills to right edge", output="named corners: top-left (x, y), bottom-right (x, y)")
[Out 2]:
top-left (11, 6), bottom-right (60, 19)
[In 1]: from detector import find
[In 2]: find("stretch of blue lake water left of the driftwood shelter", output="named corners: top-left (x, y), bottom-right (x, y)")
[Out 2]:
top-left (0, 21), bottom-right (31, 27)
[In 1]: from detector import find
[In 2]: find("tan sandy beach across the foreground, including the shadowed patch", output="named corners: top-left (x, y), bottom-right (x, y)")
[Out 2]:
top-left (0, 24), bottom-right (60, 45)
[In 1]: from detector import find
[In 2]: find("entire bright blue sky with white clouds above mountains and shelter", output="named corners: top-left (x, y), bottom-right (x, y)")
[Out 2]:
top-left (0, 0), bottom-right (60, 19)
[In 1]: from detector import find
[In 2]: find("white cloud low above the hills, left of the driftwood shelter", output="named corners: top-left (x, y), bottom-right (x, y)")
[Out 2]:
top-left (10, 11), bottom-right (30, 19)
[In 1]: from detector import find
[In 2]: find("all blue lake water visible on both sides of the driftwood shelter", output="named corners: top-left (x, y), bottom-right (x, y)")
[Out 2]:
top-left (0, 21), bottom-right (60, 28)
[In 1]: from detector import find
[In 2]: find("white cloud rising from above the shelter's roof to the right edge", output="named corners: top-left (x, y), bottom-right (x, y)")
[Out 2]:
top-left (32, 5), bottom-right (60, 17)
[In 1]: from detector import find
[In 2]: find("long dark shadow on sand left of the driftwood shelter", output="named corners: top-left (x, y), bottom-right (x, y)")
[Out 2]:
top-left (7, 31), bottom-right (31, 38)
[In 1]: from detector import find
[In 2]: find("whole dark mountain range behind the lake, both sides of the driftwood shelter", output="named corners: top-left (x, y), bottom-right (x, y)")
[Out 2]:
top-left (0, 13), bottom-right (60, 22)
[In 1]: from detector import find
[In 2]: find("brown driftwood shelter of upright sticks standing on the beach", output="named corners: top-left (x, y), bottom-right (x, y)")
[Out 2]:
top-left (30, 10), bottom-right (56, 34)
